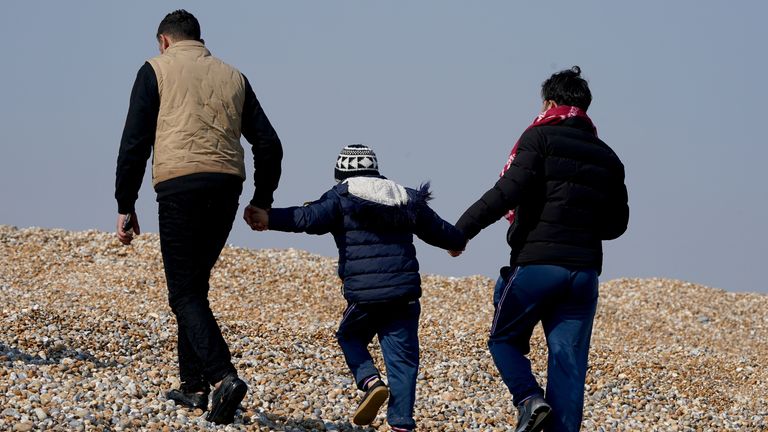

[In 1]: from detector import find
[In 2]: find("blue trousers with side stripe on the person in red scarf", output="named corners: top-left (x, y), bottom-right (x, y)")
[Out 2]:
top-left (488, 265), bottom-right (598, 432)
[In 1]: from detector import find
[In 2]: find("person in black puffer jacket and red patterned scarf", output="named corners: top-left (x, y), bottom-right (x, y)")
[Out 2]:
top-left (452, 66), bottom-right (629, 432)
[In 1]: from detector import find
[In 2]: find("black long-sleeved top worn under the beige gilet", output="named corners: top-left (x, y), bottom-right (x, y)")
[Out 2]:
top-left (115, 63), bottom-right (283, 214)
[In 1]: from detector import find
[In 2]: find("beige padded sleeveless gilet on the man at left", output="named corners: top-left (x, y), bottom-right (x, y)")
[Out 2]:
top-left (149, 40), bottom-right (245, 185)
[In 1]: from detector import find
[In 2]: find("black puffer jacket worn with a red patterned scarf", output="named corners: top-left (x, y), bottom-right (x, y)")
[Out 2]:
top-left (456, 118), bottom-right (629, 271)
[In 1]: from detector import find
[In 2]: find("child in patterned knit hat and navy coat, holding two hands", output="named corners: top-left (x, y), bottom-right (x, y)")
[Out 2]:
top-left (260, 144), bottom-right (466, 431)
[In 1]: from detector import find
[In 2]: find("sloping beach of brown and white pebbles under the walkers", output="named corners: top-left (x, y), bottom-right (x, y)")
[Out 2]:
top-left (0, 225), bottom-right (768, 432)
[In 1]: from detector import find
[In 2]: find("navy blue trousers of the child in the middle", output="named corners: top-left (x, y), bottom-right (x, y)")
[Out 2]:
top-left (336, 300), bottom-right (421, 429)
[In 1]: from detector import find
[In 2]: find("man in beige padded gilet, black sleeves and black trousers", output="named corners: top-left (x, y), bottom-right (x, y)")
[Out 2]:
top-left (115, 10), bottom-right (282, 423)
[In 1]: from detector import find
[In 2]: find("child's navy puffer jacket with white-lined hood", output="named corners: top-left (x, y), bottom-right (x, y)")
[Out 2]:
top-left (269, 177), bottom-right (466, 303)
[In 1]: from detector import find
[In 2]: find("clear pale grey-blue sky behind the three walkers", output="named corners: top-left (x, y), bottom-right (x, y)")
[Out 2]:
top-left (0, 0), bottom-right (768, 292)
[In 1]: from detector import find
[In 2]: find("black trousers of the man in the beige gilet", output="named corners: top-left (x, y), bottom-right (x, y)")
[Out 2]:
top-left (158, 182), bottom-right (242, 390)
